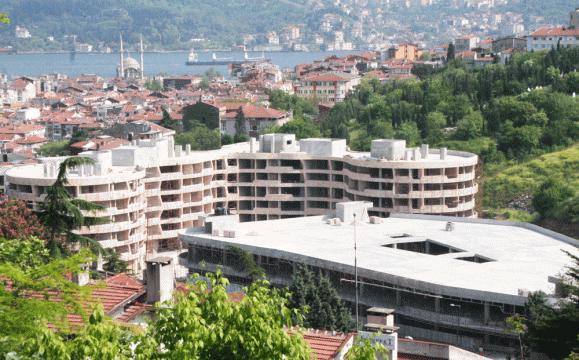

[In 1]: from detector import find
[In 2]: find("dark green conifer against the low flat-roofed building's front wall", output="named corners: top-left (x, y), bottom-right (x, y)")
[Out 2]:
top-left (289, 265), bottom-right (354, 332)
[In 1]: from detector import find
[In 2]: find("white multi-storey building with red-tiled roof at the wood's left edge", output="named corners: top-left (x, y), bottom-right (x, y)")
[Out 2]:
top-left (294, 72), bottom-right (360, 103)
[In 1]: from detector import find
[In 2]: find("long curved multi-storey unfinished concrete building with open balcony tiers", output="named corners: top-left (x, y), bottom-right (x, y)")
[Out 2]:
top-left (5, 129), bottom-right (478, 273)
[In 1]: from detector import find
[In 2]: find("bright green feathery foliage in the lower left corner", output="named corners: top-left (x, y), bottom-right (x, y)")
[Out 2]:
top-left (0, 246), bottom-right (93, 358)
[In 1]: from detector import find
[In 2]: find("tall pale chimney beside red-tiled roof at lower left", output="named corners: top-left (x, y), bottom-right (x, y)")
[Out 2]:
top-left (145, 257), bottom-right (175, 303)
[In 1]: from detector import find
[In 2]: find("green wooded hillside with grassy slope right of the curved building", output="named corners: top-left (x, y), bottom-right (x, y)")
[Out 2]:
top-left (270, 49), bottom-right (579, 233)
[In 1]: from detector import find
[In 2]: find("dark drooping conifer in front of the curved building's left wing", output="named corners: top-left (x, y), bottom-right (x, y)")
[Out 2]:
top-left (39, 157), bottom-right (108, 256)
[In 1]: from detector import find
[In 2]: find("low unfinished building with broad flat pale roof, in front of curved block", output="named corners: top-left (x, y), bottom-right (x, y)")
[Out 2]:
top-left (179, 201), bottom-right (579, 359)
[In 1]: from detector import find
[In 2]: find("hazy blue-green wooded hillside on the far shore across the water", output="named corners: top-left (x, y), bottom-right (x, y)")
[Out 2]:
top-left (0, 0), bottom-right (579, 51)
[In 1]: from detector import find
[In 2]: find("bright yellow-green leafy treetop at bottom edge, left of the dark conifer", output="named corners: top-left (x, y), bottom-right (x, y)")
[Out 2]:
top-left (136, 273), bottom-right (310, 360)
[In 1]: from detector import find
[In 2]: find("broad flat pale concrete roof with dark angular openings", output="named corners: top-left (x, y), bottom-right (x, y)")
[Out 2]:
top-left (180, 215), bottom-right (579, 304)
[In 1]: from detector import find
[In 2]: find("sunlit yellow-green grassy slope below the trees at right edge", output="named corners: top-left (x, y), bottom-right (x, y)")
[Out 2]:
top-left (484, 144), bottom-right (579, 221)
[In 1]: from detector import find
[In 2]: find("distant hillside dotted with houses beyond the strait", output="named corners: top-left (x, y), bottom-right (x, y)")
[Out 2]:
top-left (0, 0), bottom-right (579, 53)
